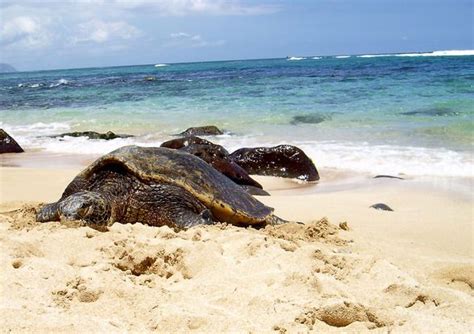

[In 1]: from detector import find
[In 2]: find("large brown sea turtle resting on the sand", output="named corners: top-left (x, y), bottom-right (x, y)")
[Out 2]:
top-left (36, 146), bottom-right (286, 228)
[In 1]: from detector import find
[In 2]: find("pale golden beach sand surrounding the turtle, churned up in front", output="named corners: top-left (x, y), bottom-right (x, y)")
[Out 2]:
top-left (0, 167), bottom-right (474, 333)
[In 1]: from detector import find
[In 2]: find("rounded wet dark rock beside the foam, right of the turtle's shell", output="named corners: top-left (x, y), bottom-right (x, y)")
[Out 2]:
top-left (230, 145), bottom-right (319, 181)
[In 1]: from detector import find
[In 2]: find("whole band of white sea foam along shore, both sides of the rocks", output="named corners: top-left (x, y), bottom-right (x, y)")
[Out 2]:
top-left (4, 122), bottom-right (474, 177)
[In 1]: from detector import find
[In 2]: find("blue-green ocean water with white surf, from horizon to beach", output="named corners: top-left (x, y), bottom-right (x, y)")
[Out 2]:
top-left (0, 51), bottom-right (474, 177)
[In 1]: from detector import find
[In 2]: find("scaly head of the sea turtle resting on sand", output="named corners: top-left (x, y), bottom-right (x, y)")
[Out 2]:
top-left (59, 191), bottom-right (111, 225)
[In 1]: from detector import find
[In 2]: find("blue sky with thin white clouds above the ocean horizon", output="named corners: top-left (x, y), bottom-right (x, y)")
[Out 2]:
top-left (0, 0), bottom-right (474, 70)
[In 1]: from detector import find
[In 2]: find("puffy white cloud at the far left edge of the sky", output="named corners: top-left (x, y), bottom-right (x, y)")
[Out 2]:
top-left (0, 16), bottom-right (53, 49)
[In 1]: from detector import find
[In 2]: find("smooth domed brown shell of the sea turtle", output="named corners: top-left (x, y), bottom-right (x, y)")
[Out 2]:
top-left (77, 146), bottom-right (273, 224)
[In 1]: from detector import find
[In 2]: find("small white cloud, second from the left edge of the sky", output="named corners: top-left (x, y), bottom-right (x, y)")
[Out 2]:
top-left (70, 20), bottom-right (141, 44)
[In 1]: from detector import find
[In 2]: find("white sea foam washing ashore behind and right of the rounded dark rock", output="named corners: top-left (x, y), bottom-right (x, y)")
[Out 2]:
top-left (218, 137), bottom-right (474, 177)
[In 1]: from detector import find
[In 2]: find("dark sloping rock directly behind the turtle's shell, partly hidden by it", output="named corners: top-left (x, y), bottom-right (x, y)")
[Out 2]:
top-left (161, 137), bottom-right (262, 189)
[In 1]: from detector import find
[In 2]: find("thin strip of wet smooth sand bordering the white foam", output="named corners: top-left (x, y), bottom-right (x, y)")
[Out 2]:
top-left (0, 150), bottom-right (474, 201)
